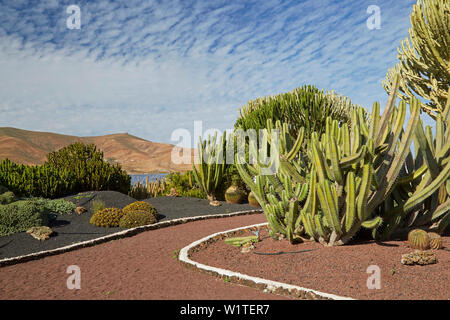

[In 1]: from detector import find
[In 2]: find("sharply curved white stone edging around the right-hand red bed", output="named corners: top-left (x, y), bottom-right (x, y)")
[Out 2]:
top-left (178, 222), bottom-right (354, 300)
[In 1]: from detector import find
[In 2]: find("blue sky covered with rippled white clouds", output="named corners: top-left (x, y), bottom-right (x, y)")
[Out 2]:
top-left (0, 0), bottom-right (416, 148)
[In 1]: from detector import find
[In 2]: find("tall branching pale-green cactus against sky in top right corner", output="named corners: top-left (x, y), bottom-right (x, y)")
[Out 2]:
top-left (383, 0), bottom-right (450, 118)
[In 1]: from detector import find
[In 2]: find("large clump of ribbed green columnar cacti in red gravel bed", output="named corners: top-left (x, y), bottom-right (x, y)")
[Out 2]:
top-left (238, 78), bottom-right (450, 245)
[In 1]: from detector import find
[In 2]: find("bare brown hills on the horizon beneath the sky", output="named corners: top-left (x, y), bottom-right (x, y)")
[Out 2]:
top-left (0, 128), bottom-right (193, 174)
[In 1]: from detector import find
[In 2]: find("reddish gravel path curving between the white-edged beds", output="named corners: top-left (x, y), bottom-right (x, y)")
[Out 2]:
top-left (0, 214), bottom-right (283, 300)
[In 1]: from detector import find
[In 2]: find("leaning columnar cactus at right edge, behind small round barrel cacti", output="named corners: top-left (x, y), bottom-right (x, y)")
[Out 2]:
top-left (378, 89), bottom-right (450, 239)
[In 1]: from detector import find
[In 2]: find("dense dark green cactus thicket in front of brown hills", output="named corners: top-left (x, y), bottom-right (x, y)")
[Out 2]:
top-left (0, 143), bottom-right (131, 198)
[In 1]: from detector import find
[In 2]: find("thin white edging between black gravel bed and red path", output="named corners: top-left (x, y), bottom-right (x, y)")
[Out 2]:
top-left (0, 209), bottom-right (262, 268)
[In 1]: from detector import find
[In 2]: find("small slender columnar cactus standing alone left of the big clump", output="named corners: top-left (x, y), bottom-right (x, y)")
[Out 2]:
top-left (192, 132), bottom-right (226, 201)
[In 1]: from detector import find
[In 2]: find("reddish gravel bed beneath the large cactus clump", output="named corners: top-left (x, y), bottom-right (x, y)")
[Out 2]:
top-left (189, 227), bottom-right (450, 300)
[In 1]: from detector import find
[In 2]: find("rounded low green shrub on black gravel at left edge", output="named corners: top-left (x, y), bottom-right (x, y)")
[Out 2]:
top-left (0, 200), bottom-right (48, 236)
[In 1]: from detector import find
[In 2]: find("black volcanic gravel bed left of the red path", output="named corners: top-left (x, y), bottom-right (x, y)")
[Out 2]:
top-left (0, 191), bottom-right (255, 260)
